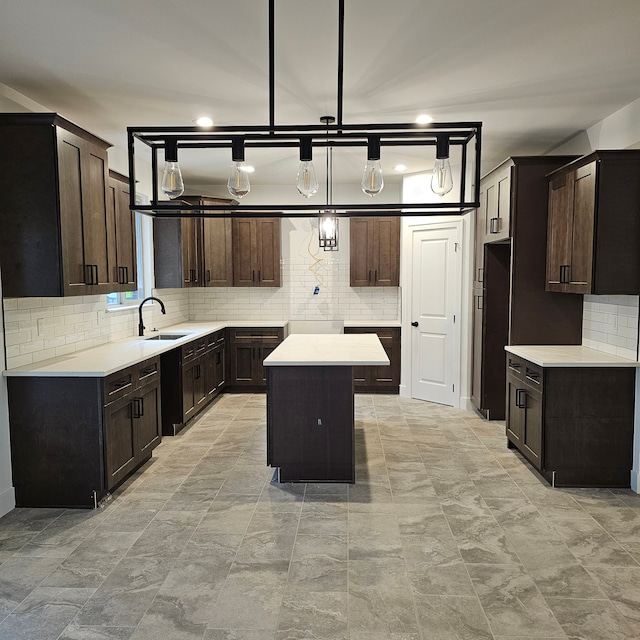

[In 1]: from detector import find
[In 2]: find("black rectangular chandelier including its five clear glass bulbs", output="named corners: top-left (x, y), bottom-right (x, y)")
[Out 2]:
top-left (127, 0), bottom-right (482, 218)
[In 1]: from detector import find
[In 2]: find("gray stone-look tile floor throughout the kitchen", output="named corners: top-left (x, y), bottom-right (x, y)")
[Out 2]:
top-left (0, 395), bottom-right (640, 640)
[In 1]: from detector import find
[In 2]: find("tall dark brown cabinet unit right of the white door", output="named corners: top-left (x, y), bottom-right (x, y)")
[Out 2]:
top-left (471, 156), bottom-right (582, 420)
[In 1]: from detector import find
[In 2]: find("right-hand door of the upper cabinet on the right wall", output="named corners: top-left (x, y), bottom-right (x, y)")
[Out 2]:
top-left (568, 162), bottom-right (596, 293)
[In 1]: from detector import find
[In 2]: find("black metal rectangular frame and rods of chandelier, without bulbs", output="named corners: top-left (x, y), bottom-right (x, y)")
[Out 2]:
top-left (127, 0), bottom-right (482, 218)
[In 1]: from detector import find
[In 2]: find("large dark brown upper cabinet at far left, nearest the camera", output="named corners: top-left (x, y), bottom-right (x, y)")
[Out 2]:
top-left (0, 113), bottom-right (117, 297)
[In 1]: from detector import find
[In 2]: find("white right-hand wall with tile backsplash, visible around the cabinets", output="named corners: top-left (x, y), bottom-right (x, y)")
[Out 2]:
top-left (550, 99), bottom-right (640, 493)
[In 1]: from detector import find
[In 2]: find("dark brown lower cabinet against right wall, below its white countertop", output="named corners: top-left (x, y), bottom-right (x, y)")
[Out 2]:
top-left (506, 353), bottom-right (635, 487)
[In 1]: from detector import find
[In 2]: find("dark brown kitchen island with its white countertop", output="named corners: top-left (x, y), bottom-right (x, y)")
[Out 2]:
top-left (263, 333), bottom-right (389, 483)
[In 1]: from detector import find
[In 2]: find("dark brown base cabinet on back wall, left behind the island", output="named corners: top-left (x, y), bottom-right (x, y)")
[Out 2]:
top-left (227, 327), bottom-right (284, 392)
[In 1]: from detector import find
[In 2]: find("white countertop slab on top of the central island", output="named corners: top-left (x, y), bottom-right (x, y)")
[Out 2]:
top-left (263, 333), bottom-right (389, 367)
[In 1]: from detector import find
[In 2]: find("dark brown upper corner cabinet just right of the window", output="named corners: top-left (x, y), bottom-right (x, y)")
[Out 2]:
top-left (153, 196), bottom-right (235, 289)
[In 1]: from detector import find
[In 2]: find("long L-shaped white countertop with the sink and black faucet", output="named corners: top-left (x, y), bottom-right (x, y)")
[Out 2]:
top-left (4, 320), bottom-right (287, 378)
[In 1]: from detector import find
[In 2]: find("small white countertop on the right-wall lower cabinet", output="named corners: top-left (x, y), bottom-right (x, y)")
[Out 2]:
top-left (505, 345), bottom-right (640, 367)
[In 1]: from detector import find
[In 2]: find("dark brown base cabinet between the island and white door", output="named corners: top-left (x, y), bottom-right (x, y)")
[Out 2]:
top-left (344, 326), bottom-right (400, 394)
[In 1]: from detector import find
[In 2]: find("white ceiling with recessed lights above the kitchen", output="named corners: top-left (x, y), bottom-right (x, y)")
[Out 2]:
top-left (0, 0), bottom-right (640, 189)
